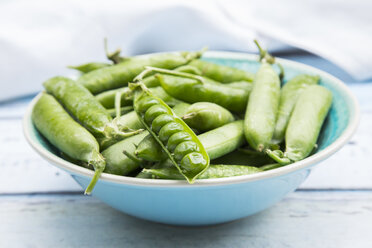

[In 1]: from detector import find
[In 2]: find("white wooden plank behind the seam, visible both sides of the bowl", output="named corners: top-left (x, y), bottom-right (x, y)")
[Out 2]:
top-left (0, 84), bottom-right (372, 193)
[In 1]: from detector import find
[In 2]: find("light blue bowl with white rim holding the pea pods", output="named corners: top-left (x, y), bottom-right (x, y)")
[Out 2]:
top-left (23, 52), bottom-right (359, 225)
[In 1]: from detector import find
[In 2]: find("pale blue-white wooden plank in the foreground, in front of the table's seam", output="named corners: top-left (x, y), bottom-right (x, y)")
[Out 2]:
top-left (0, 191), bottom-right (372, 248)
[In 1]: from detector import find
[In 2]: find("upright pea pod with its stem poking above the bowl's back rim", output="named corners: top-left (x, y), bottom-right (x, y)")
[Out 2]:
top-left (244, 40), bottom-right (280, 152)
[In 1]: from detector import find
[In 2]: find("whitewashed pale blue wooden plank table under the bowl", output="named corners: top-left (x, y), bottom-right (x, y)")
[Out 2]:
top-left (0, 54), bottom-right (372, 248)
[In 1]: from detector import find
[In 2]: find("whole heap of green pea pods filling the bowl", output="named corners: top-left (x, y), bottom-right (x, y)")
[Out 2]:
top-left (32, 42), bottom-right (332, 194)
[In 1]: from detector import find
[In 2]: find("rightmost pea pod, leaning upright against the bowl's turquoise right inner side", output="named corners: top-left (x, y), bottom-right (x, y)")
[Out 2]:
top-left (267, 85), bottom-right (332, 165)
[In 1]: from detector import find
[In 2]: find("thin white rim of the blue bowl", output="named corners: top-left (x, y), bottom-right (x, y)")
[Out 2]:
top-left (23, 51), bottom-right (360, 187)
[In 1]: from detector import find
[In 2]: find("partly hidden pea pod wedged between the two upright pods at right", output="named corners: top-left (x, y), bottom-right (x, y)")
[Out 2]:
top-left (272, 74), bottom-right (319, 144)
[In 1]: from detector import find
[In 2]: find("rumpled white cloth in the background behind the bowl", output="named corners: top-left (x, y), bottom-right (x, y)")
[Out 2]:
top-left (0, 0), bottom-right (372, 100)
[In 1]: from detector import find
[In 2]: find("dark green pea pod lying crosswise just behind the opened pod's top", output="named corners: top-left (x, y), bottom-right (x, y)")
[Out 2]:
top-left (156, 73), bottom-right (249, 113)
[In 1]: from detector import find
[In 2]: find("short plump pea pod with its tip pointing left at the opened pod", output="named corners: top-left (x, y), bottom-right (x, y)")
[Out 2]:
top-left (182, 102), bottom-right (234, 132)
